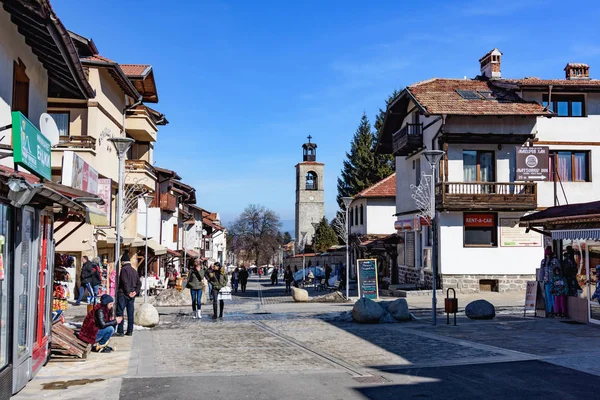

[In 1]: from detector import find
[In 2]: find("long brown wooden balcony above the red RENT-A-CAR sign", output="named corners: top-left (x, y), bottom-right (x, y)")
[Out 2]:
top-left (436, 182), bottom-right (537, 211)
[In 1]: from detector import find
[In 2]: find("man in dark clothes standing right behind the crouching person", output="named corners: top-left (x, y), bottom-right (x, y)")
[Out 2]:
top-left (115, 253), bottom-right (141, 336)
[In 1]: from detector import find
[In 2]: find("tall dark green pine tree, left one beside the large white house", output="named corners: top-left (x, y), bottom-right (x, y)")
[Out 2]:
top-left (337, 111), bottom-right (395, 208)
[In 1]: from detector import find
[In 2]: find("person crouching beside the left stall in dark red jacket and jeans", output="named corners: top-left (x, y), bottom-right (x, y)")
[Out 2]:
top-left (79, 294), bottom-right (123, 353)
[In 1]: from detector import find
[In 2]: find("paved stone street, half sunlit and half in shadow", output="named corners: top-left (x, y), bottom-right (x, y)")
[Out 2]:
top-left (15, 281), bottom-right (600, 399)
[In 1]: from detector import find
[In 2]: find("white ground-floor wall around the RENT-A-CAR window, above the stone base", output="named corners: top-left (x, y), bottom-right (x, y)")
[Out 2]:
top-left (439, 212), bottom-right (544, 275)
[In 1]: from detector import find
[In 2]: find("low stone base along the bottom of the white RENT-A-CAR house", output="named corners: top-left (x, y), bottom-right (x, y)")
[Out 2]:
top-left (442, 274), bottom-right (535, 293)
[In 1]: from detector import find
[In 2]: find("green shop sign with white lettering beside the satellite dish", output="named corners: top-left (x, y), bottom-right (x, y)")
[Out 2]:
top-left (12, 111), bottom-right (52, 180)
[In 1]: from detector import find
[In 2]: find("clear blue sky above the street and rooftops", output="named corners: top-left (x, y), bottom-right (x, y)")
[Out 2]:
top-left (52, 0), bottom-right (600, 229)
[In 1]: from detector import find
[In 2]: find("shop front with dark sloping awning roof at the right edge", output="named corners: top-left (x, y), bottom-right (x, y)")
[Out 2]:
top-left (521, 201), bottom-right (600, 324)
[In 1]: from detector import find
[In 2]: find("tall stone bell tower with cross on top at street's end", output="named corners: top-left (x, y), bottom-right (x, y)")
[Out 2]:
top-left (296, 136), bottom-right (325, 244)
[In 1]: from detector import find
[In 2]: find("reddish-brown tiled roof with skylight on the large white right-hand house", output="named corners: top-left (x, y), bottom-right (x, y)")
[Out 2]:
top-left (407, 78), bottom-right (552, 115)
